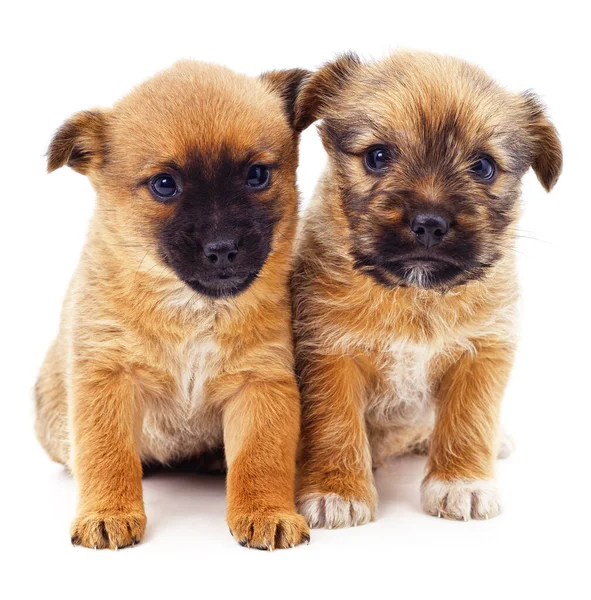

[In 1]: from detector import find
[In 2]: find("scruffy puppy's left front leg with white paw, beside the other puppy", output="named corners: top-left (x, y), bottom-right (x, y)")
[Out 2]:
top-left (297, 356), bottom-right (377, 528)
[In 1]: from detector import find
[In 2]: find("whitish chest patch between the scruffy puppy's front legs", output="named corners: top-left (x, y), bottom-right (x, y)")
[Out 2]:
top-left (367, 343), bottom-right (439, 427)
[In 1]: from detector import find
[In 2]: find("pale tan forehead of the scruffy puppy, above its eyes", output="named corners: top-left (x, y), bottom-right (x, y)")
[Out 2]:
top-left (345, 53), bottom-right (516, 148)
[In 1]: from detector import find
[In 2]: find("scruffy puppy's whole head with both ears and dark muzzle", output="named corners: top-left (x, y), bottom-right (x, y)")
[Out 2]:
top-left (296, 53), bottom-right (562, 289)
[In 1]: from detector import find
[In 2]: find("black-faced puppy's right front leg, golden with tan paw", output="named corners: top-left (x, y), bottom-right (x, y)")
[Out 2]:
top-left (224, 373), bottom-right (310, 550)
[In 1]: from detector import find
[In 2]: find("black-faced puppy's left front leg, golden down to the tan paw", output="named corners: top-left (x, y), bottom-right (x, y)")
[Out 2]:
top-left (71, 364), bottom-right (146, 549)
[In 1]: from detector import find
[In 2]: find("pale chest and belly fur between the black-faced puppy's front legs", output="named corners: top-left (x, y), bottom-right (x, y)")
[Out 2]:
top-left (142, 337), bottom-right (222, 463)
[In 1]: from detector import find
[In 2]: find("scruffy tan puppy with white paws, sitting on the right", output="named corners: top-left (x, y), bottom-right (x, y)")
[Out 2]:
top-left (293, 53), bottom-right (562, 527)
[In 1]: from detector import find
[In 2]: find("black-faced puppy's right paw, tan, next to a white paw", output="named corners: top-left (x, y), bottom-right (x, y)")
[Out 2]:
top-left (228, 508), bottom-right (310, 550)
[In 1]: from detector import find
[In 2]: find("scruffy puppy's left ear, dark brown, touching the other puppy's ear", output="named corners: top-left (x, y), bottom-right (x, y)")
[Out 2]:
top-left (295, 52), bottom-right (361, 130)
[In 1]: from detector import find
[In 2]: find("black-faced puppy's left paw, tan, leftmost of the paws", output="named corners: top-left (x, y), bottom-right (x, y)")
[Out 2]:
top-left (70, 511), bottom-right (146, 550)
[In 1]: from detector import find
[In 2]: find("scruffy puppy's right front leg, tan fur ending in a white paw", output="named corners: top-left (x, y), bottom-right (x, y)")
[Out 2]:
top-left (421, 341), bottom-right (514, 521)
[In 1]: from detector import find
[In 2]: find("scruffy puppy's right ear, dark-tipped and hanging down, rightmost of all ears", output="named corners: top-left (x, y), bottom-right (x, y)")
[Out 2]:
top-left (521, 92), bottom-right (562, 192)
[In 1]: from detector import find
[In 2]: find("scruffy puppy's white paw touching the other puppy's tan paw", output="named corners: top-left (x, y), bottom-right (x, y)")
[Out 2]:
top-left (297, 493), bottom-right (375, 529)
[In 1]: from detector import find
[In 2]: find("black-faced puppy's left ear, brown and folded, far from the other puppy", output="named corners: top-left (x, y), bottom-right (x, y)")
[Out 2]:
top-left (47, 110), bottom-right (106, 175)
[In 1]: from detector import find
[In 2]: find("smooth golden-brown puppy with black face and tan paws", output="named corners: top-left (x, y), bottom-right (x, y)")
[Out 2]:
top-left (36, 61), bottom-right (309, 549)
